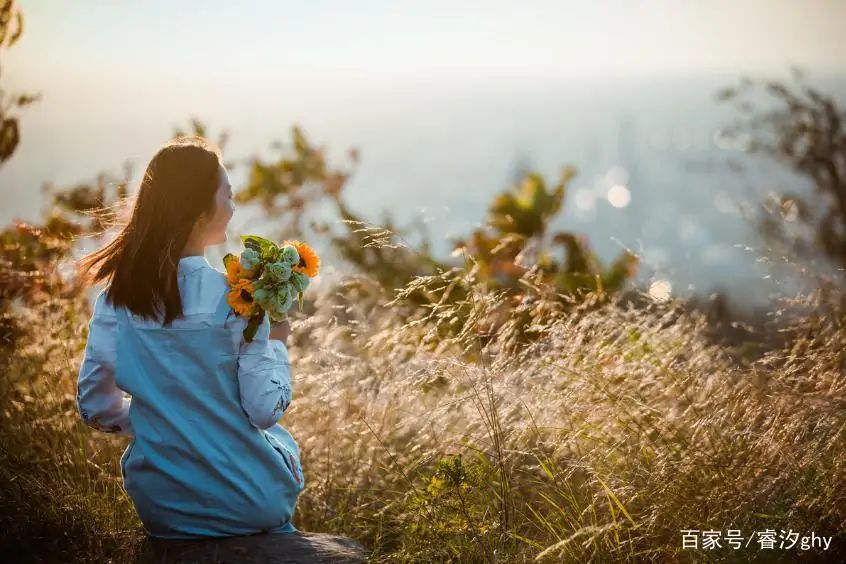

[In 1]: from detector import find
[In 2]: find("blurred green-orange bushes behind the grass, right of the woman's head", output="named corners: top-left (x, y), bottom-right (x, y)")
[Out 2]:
top-left (236, 127), bottom-right (637, 348)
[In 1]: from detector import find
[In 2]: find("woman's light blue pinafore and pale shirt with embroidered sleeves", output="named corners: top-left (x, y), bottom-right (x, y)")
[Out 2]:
top-left (77, 256), bottom-right (305, 538)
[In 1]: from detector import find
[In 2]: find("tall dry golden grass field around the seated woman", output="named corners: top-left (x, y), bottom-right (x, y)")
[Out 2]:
top-left (0, 260), bottom-right (846, 562)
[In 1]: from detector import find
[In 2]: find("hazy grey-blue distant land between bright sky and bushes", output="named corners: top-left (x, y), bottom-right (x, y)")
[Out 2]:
top-left (6, 71), bottom-right (846, 307)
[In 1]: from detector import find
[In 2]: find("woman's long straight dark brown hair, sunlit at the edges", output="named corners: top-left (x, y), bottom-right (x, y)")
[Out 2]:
top-left (77, 137), bottom-right (221, 325)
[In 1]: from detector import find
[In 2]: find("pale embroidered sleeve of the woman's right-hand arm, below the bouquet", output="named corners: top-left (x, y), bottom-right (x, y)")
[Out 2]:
top-left (236, 315), bottom-right (292, 429)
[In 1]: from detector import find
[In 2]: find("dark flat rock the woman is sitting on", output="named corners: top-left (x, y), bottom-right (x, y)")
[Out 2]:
top-left (137, 531), bottom-right (368, 564)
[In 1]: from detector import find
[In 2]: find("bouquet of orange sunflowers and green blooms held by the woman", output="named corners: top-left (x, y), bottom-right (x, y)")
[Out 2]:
top-left (223, 235), bottom-right (320, 342)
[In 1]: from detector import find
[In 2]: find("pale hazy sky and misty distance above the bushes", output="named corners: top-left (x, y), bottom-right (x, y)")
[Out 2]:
top-left (0, 0), bottom-right (846, 309)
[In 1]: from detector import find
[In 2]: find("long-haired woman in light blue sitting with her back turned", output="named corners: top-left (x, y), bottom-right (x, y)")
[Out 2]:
top-left (76, 137), bottom-right (305, 539)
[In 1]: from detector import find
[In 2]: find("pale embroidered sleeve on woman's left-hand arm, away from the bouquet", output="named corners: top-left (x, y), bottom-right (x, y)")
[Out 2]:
top-left (76, 292), bottom-right (135, 436)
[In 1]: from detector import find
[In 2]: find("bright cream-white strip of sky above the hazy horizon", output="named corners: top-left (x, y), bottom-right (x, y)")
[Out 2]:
top-left (4, 0), bottom-right (846, 87)
